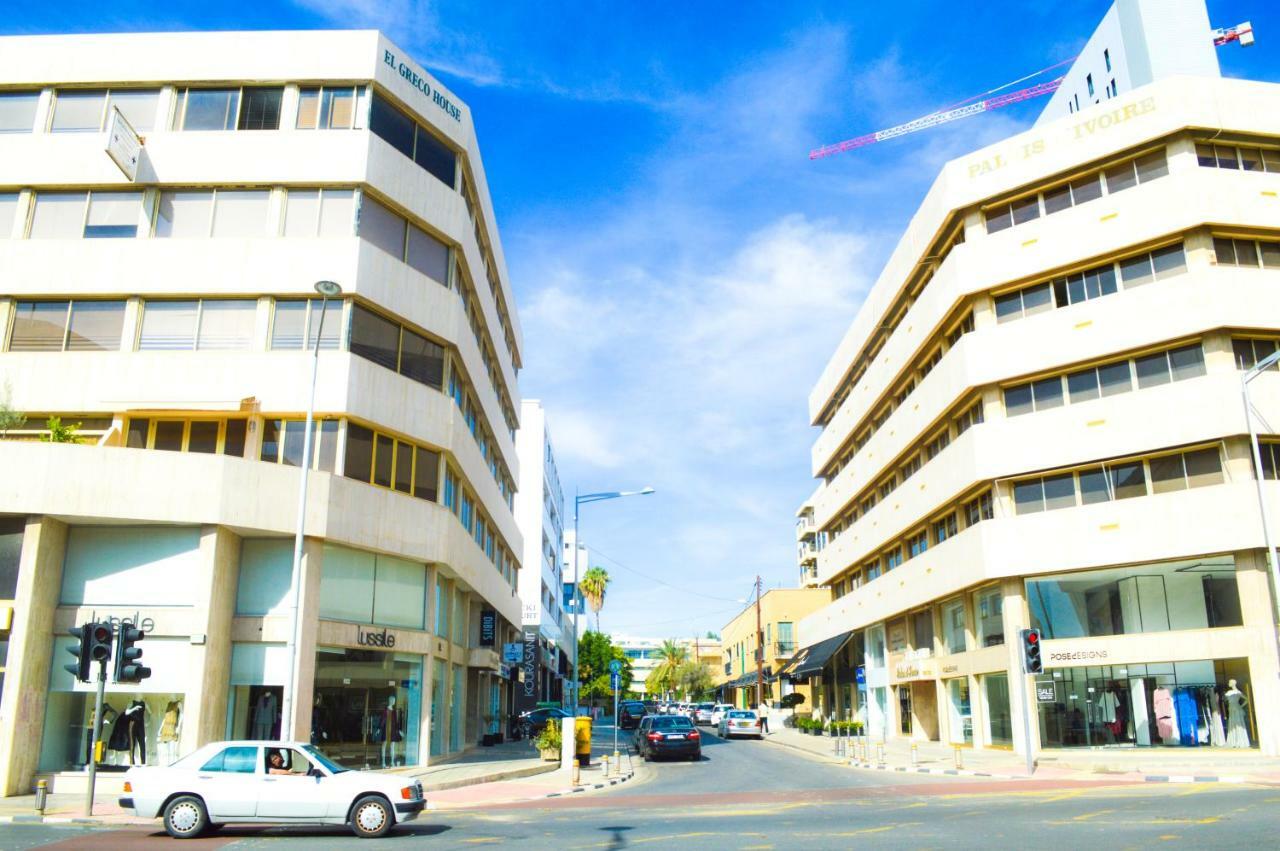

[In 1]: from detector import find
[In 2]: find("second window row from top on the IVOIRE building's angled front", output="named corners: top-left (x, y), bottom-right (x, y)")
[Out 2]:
top-left (996, 242), bottom-right (1187, 322)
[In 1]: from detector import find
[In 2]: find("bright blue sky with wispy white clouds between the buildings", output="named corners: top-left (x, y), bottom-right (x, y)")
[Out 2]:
top-left (0, 0), bottom-right (1280, 637)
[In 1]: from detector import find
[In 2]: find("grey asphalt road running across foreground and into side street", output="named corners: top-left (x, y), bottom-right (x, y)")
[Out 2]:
top-left (10, 728), bottom-right (1280, 851)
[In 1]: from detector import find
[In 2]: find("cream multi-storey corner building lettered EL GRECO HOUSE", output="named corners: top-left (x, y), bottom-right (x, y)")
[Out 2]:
top-left (0, 32), bottom-right (522, 795)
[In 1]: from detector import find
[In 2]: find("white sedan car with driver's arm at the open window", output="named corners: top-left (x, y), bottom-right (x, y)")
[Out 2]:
top-left (120, 741), bottom-right (426, 839)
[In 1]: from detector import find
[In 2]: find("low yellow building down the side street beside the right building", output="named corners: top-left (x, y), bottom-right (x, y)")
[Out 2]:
top-left (716, 587), bottom-right (831, 712)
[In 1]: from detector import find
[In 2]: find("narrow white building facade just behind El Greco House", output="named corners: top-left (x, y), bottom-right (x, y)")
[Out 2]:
top-left (516, 399), bottom-right (570, 712)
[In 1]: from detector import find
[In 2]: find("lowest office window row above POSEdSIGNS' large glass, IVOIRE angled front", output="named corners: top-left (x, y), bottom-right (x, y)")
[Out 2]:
top-left (1014, 447), bottom-right (1224, 514)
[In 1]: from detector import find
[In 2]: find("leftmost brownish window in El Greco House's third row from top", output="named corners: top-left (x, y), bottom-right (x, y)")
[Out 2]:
top-left (9, 301), bottom-right (124, 352)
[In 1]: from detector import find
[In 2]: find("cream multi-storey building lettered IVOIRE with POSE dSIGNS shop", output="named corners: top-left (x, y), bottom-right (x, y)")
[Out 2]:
top-left (800, 4), bottom-right (1280, 755)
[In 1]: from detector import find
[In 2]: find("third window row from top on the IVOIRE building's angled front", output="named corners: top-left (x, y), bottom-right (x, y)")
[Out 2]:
top-left (1005, 343), bottom-right (1204, 417)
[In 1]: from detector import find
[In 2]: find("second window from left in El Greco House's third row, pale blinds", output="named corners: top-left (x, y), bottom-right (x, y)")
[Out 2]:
top-left (138, 298), bottom-right (257, 351)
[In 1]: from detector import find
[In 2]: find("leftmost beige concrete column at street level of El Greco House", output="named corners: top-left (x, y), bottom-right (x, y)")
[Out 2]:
top-left (0, 517), bottom-right (72, 796)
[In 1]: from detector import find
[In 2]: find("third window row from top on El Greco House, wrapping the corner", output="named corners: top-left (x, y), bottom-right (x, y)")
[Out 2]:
top-left (8, 298), bottom-right (515, 505)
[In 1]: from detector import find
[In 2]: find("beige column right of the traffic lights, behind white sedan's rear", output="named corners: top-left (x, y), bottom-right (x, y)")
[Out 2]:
top-left (185, 526), bottom-right (241, 754)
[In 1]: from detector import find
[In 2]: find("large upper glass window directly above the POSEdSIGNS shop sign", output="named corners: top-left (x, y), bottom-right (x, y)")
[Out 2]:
top-left (1027, 555), bottom-right (1243, 639)
